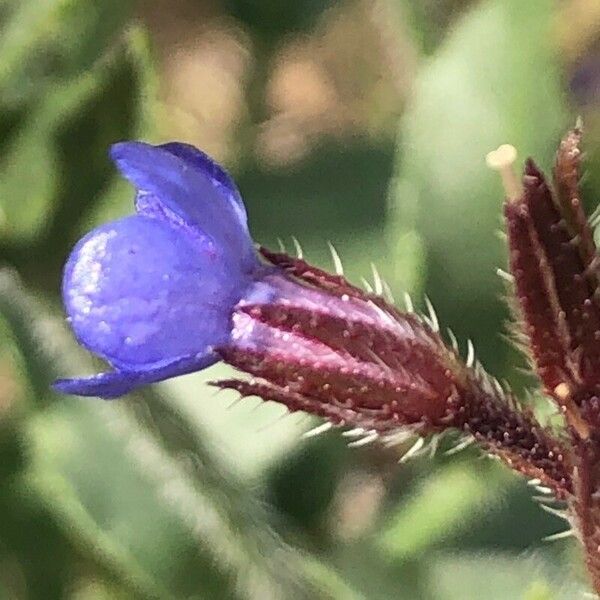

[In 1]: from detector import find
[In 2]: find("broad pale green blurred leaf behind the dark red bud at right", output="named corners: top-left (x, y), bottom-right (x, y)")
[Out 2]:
top-left (392, 0), bottom-right (567, 370)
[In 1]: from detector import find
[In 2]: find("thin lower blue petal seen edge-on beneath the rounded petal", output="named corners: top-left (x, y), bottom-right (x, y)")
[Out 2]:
top-left (53, 352), bottom-right (219, 398)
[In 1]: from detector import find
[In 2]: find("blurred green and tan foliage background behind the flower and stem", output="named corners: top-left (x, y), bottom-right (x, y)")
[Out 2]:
top-left (0, 0), bottom-right (600, 600)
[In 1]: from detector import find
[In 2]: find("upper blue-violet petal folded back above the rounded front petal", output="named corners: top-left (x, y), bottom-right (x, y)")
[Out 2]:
top-left (111, 142), bottom-right (256, 270)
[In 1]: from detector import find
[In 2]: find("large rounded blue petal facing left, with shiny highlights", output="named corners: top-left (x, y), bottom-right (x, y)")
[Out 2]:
top-left (63, 216), bottom-right (249, 371)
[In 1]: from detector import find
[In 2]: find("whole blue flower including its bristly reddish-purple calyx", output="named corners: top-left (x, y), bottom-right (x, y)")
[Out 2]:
top-left (55, 142), bottom-right (466, 433)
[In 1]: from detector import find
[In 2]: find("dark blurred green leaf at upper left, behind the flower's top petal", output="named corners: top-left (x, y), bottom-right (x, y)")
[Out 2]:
top-left (0, 30), bottom-right (152, 286)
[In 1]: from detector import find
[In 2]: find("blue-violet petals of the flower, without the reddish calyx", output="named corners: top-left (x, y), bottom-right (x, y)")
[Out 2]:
top-left (55, 142), bottom-right (265, 398)
